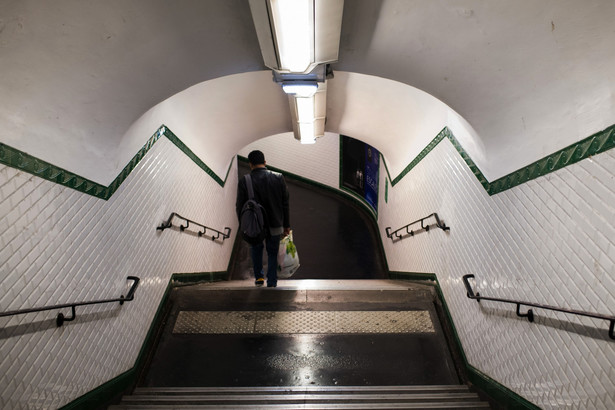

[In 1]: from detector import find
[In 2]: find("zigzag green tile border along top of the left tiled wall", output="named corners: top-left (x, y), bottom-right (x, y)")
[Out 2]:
top-left (0, 125), bottom-right (233, 200)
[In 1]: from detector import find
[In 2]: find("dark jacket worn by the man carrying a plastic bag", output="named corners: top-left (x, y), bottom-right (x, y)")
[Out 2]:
top-left (235, 168), bottom-right (290, 235)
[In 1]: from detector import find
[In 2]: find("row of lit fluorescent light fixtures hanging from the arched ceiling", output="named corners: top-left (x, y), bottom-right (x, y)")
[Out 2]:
top-left (249, 0), bottom-right (344, 144)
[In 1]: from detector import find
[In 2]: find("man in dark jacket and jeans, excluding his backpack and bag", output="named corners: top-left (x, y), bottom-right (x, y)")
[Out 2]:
top-left (235, 150), bottom-right (290, 288)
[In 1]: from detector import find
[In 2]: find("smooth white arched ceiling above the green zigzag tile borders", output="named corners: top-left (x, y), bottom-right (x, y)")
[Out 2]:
top-left (0, 0), bottom-right (615, 183)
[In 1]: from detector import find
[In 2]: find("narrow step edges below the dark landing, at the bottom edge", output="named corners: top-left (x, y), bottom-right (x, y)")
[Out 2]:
top-left (109, 385), bottom-right (490, 410)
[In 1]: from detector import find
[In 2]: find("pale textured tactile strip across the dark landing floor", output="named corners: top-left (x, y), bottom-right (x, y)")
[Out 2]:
top-left (173, 310), bottom-right (435, 334)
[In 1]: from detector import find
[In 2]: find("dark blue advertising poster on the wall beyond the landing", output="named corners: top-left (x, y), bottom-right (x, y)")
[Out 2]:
top-left (342, 136), bottom-right (380, 212)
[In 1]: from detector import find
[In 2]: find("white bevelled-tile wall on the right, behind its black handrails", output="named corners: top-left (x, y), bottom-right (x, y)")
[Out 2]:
top-left (379, 139), bottom-right (615, 409)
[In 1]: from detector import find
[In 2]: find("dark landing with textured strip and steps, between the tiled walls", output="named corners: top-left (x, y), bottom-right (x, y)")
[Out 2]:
top-left (109, 280), bottom-right (490, 410)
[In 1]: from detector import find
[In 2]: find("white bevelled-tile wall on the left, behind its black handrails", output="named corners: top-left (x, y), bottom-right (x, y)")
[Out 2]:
top-left (0, 138), bottom-right (237, 409)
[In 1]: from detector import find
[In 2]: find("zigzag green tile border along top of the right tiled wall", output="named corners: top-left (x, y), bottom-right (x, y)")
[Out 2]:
top-left (382, 125), bottom-right (615, 195)
